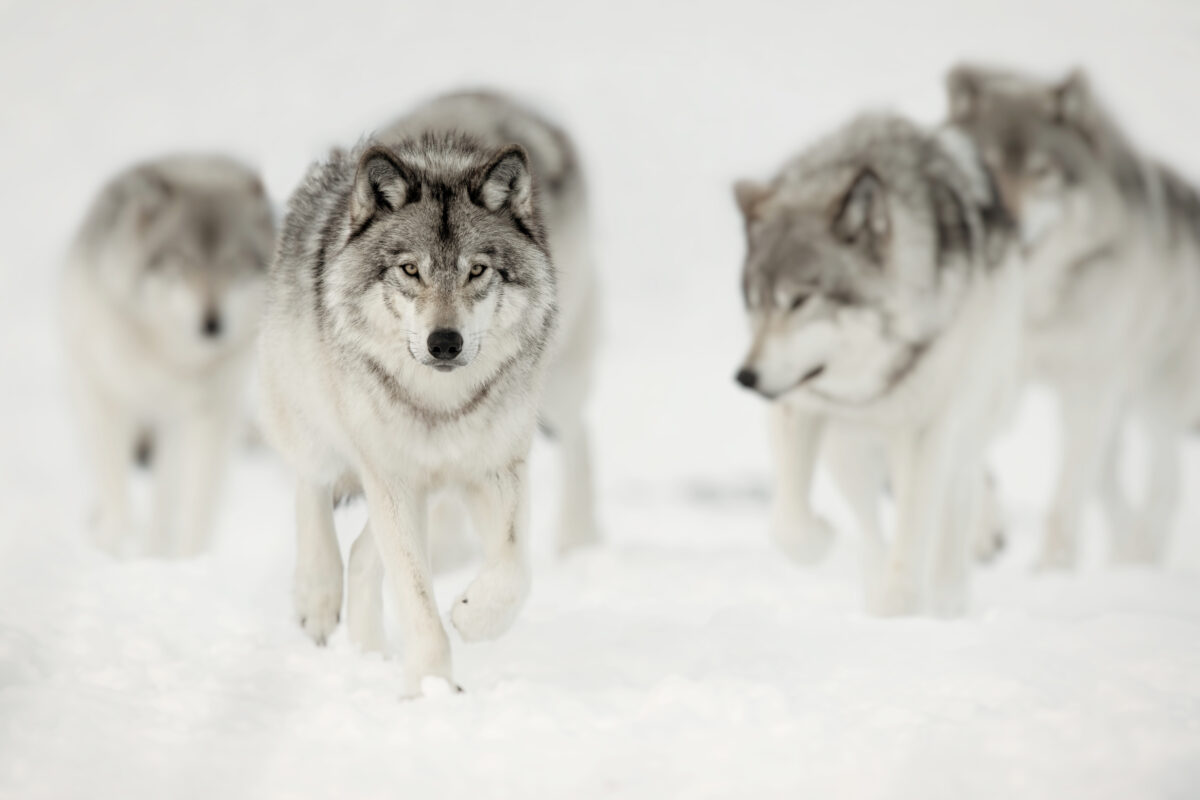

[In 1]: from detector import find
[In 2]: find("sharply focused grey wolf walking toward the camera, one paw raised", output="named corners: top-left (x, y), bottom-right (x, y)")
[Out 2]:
top-left (259, 101), bottom-right (558, 696)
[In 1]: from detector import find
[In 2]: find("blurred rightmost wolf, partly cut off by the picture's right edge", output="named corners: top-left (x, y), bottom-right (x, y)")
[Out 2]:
top-left (947, 66), bottom-right (1200, 567)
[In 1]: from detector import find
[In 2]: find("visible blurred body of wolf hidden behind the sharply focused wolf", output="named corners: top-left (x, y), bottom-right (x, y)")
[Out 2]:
top-left (377, 91), bottom-right (599, 561)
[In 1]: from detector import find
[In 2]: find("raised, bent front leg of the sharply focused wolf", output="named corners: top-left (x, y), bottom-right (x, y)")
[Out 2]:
top-left (450, 458), bottom-right (530, 642)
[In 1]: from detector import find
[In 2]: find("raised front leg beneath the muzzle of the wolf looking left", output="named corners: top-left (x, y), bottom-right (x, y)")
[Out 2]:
top-left (770, 403), bottom-right (833, 564)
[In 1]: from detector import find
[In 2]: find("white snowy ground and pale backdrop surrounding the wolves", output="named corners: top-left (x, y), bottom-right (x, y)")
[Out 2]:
top-left (0, 0), bottom-right (1200, 799)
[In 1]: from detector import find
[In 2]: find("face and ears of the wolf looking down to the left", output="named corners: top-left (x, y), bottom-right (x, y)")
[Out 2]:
top-left (738, 168), bottom-right (910, 401)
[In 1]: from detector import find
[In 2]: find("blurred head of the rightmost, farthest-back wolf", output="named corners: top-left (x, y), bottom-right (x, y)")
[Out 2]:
top-left (947, 66), bottom-right (1141, 253)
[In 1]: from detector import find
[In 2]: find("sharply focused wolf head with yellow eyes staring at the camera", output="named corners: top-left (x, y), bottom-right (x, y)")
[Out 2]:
top-left (322, 136), bottom-right (554, 372)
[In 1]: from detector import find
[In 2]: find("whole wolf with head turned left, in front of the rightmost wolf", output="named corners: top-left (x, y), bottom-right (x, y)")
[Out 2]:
top-left (736, 116), bottom-right (1021, 615)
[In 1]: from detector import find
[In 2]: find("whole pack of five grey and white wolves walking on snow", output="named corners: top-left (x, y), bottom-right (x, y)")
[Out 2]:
top-left (61, 66), bottom-right (1200, 696)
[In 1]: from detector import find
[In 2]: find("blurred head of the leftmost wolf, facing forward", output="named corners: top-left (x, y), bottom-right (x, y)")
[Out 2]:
top-left (100, 157), bottom-right (275, 363)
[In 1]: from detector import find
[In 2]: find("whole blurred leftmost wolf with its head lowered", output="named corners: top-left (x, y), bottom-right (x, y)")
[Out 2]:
top-left (60, 155), bottom-right (275, 555)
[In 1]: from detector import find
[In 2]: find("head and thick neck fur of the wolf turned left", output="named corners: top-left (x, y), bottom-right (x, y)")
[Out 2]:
top-left (736, 118), bottom-right (993, 404)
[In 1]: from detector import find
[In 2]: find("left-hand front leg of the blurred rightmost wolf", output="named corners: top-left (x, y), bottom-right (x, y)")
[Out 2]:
top-left (1038, 381), bottom-right (1122, 570)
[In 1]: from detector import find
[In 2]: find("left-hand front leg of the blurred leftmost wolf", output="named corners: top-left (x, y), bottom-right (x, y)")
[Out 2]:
top-left (76, 385), bottom-right (137, 555)
